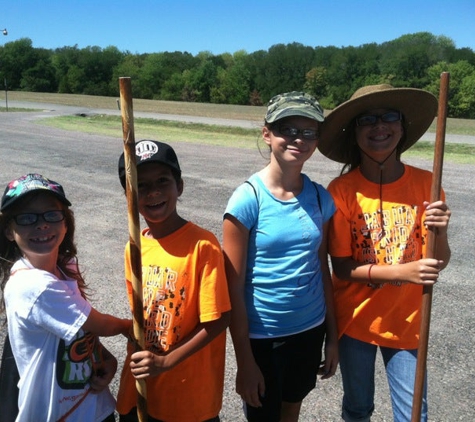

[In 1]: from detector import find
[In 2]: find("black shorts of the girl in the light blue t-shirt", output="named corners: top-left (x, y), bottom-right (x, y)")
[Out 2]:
top-left (245, 324), bottom-right (325, 422)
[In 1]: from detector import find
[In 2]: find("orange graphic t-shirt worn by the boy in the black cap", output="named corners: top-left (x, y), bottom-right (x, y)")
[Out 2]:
top-left (117, 222), bottom-right (231, 422)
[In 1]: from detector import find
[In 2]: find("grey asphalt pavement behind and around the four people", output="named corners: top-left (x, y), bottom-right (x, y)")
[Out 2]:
top-left (0, 104), bottom-right (475, 422)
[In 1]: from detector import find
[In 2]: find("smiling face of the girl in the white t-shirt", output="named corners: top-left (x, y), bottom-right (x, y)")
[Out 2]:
top-left (5, 193), bottom-right (67, 270)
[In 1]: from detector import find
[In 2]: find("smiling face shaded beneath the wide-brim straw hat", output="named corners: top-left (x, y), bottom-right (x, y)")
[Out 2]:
top-left (355, 109), bottom-right (404, 161)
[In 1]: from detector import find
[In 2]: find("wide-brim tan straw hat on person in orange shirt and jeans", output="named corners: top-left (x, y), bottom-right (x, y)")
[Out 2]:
top-left (318, 84), bottom-right (437, 164)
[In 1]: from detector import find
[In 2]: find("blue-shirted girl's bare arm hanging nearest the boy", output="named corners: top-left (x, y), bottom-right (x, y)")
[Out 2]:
top-left (223, 215), bottom-right (265, 407)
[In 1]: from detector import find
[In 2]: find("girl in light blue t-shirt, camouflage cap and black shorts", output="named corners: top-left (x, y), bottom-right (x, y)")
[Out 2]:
top-left (223, 92), bottom-right (338, 422)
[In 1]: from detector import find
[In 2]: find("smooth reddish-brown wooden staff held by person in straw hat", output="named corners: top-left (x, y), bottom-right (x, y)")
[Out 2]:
top-left (411, 72), bottom-right (450, 422)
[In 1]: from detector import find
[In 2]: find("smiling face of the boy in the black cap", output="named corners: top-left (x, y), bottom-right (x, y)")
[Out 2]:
top-left (137, 162), bottom-right (183, 231)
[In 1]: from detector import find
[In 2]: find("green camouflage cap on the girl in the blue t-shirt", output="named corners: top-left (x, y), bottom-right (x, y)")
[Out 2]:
top-left (265, 91), bottom-right (324, 123)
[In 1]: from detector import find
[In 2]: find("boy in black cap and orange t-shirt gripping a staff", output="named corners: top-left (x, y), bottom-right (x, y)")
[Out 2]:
top-left (117, 140), bottom-right (231, 422)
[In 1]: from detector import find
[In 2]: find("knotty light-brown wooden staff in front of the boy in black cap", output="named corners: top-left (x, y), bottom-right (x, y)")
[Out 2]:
top-left (119, 78), bottom-right (147, 422)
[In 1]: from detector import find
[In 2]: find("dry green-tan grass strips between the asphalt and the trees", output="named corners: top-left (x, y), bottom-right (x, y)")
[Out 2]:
top-left (0, 91), bottom-right (475, 164)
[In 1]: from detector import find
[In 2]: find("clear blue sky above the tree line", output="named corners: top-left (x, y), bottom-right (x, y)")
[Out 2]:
top-left (0, 0), bottom-right (475, 55)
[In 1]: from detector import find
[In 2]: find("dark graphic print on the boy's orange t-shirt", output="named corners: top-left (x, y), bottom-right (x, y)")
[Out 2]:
top-left (142, 265), bottom-right (185, 352)
